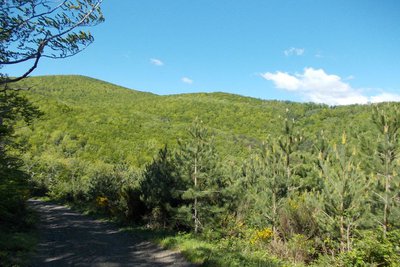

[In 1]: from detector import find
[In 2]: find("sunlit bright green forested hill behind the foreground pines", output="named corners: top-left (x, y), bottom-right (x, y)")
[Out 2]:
top-left (19, 76), bottom-right (373, 167)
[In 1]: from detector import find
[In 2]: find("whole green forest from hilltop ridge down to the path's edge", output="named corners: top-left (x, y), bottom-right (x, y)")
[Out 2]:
top-left (3, 76), bottom-right (400, 266)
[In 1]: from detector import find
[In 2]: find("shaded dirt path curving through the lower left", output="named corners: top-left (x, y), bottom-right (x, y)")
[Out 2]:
top-left (29, 200), bottom-right (193, 267)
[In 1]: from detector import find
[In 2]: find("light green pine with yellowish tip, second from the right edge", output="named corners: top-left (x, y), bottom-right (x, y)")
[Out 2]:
top-left (319, 133), bottom-right (369, 252)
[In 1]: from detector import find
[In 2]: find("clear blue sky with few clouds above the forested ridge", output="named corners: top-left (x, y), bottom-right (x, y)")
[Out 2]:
top-left (4, 0), bottom-right (400, 105)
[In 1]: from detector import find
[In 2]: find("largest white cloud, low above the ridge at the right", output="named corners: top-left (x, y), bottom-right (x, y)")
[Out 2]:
top-left (261, 68), bottom-right (400, 105)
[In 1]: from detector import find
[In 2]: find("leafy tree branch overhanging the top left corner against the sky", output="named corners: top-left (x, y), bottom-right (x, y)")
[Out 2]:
top-left (0, 0), bottom-right (104, 85)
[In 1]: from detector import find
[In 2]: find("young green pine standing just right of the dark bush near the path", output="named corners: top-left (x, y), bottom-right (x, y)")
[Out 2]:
top-left (177, 119), bottom-right (223, 233)
